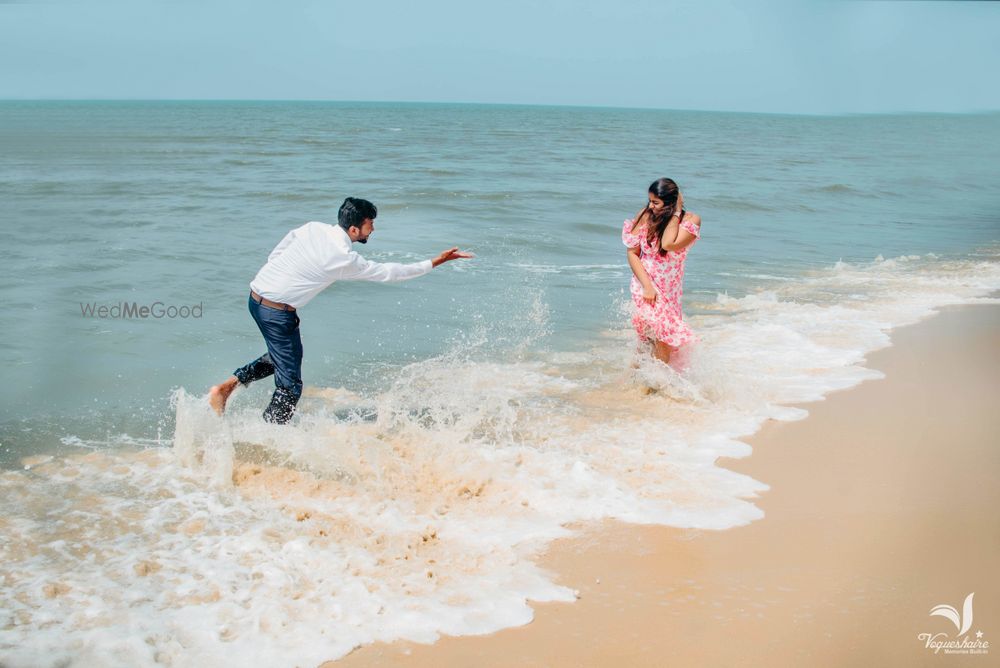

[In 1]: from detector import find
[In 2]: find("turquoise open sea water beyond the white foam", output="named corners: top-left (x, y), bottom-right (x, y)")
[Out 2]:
top-left (0, 102), bottom-right (1000, 460)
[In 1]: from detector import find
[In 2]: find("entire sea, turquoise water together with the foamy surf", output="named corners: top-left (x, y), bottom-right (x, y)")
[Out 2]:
top-left (0, 102), bottom-right (1000, 666)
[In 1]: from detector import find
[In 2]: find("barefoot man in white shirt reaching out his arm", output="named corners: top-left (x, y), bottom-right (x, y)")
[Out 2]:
top-left (208, 197), bottom-right (473, 424)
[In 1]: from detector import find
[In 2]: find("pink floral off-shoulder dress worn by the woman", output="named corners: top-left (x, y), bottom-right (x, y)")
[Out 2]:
top-left (622, 216), bottom-right (701, 348)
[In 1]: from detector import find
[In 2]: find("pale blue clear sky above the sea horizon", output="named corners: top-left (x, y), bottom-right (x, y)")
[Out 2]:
top-left (0, 0), bottom-right (1000, 113)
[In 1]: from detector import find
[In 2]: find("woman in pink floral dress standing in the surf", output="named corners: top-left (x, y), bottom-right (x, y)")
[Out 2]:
top-left (622, 179), bottom-right (701, 364)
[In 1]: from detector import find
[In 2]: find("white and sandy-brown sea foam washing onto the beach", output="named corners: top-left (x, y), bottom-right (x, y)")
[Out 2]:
top-left (0, 256), bottom-right (1000, 666)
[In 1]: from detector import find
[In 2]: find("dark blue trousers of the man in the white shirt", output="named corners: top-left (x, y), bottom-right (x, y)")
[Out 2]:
top-left (233, 297), bottom-right (302, 424)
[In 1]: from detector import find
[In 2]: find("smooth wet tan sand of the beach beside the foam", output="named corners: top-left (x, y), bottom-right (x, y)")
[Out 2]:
top-left (336, 305), bottom-right (1000, 668)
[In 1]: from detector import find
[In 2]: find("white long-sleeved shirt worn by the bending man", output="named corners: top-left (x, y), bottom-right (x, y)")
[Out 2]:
top-left (250, 222), bottom-right (433, 309)
